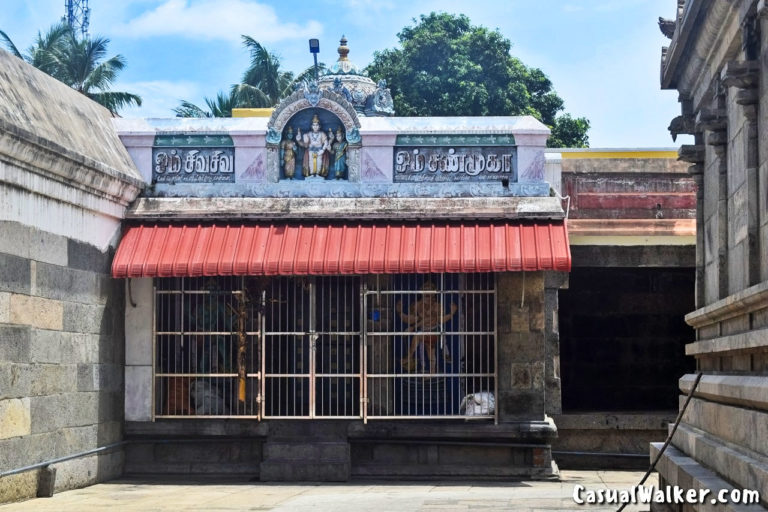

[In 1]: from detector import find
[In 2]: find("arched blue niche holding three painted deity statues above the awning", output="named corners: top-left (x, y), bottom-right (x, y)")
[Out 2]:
top-left (279, 111), bottom-right (349, 180)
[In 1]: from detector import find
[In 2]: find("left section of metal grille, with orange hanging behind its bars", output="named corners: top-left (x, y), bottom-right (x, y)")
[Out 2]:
top-left (153, 277), bottom-right (262, 419)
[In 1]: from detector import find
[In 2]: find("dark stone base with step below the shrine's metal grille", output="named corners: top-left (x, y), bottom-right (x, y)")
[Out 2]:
top-left (125, 419), bottom-right (559, 482)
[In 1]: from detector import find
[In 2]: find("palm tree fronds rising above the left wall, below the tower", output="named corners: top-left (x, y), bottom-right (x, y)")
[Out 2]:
top-left (0, 22), bottom-right (141, 115)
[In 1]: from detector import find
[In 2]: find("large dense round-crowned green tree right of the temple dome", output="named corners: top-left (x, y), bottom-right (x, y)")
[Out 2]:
top-left (366, 13), bottom-right (589, 147)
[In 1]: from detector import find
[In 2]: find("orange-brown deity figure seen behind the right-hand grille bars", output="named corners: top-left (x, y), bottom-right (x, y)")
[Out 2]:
top-left (395, 281), bottom-right (458, 373)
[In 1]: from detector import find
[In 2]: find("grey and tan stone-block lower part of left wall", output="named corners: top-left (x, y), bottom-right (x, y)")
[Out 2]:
top-left (0, 221), bottom-right (124, 502)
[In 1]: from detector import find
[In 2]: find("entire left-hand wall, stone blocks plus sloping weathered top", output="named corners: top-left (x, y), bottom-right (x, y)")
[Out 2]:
top-left (0, 51), bottom-right (143, 503)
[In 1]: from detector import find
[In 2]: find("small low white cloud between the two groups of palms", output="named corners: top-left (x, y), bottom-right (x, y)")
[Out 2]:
top-left (112, 80), bottom-right (203, 117)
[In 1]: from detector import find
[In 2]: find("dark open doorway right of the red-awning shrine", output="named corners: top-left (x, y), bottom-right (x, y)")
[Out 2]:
top-left (560, 267), bottom-right (695, 412)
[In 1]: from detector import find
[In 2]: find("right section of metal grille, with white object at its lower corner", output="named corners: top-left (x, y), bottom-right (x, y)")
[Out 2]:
top-left (364, 274), bottom-right (497, 419)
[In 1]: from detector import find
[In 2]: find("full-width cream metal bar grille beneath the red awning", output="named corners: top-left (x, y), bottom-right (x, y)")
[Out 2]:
top-left (154, 274), bottom-right (497, 421)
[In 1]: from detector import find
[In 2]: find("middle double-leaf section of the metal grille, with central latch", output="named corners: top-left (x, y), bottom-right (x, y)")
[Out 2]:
top-left (263, 277), bottom-right (362, 418)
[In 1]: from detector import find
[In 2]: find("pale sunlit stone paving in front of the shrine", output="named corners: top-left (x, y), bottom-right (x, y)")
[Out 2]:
top-left (0, 471), bottom-right (656, 512)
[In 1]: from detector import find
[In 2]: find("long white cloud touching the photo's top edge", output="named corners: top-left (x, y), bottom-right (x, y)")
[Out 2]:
top-left (114, 0), bottom-right (322, 43)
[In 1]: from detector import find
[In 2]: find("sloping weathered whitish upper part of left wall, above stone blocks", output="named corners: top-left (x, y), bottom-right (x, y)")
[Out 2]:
top-left (0, 52), bottom-right (144, 251)
